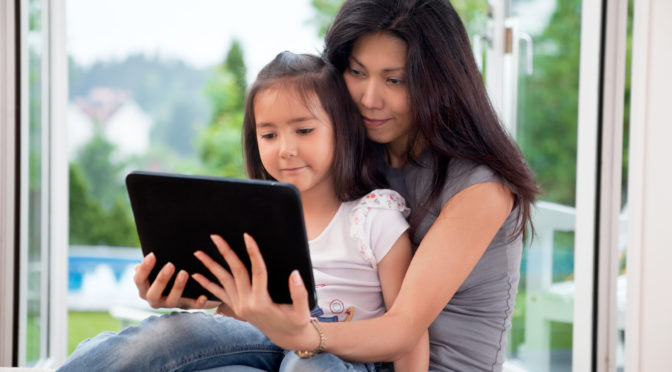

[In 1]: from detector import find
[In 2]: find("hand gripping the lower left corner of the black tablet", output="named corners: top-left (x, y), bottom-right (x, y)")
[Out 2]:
top-left (133, 253), bottom-right (219, 309)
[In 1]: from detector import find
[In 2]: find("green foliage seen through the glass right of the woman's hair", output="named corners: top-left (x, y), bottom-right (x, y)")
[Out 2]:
top-left (517, 0), bottom-right (581, 205)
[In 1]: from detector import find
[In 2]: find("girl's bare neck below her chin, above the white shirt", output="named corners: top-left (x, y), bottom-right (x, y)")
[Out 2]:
top-left (301, 185), bottom-right (341, 240)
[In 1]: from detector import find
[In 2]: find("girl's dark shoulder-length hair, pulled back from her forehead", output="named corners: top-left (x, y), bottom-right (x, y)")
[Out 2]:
top-left (243, 52), bottom-right (385, 201)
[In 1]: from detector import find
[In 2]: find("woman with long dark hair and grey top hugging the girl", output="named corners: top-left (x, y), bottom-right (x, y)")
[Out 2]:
top-left (197, 0), bottom-right (538, 371)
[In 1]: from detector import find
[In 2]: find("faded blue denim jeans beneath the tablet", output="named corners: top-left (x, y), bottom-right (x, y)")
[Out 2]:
top-left (58, 312), bottom-right (384, 372)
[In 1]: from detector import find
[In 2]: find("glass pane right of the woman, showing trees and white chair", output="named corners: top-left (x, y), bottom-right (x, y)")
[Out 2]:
top-left (507, 0), bottom-right (581, 372)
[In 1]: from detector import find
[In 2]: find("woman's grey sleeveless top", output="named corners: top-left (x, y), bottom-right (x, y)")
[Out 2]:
top-left (379, 152), bottom-right (522, 372)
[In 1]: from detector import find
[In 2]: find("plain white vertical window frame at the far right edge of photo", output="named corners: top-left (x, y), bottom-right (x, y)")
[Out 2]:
top-left (625, 0), bottom-right (672, 371)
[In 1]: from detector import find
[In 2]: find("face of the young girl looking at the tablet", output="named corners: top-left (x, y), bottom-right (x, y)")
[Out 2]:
top-left (254, 87), bottom-right (334, 198)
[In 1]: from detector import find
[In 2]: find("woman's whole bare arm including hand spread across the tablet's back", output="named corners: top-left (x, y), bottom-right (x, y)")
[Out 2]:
top-left (194, 182), bottom-right (513, 362)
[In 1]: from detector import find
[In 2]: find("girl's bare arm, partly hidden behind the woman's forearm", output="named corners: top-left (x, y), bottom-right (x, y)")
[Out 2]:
top-left (378, 231), bottom-right (429, 372)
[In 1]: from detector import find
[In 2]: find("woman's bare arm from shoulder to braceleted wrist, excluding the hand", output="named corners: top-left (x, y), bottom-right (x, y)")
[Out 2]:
top-left (322, 182), bottom-right (513, 361)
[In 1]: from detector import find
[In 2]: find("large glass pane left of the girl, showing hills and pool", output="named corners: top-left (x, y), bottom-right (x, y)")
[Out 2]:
top-left (66, 0), bottom-right (322, 352)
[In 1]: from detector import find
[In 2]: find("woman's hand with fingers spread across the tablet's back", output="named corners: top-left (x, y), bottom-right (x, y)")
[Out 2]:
top-left (192, 234), bottom-right (320, 350)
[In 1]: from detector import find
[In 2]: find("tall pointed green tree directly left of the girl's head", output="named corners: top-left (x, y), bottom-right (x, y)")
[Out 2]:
top-left (199, 40), bottom-right (247, 177)
